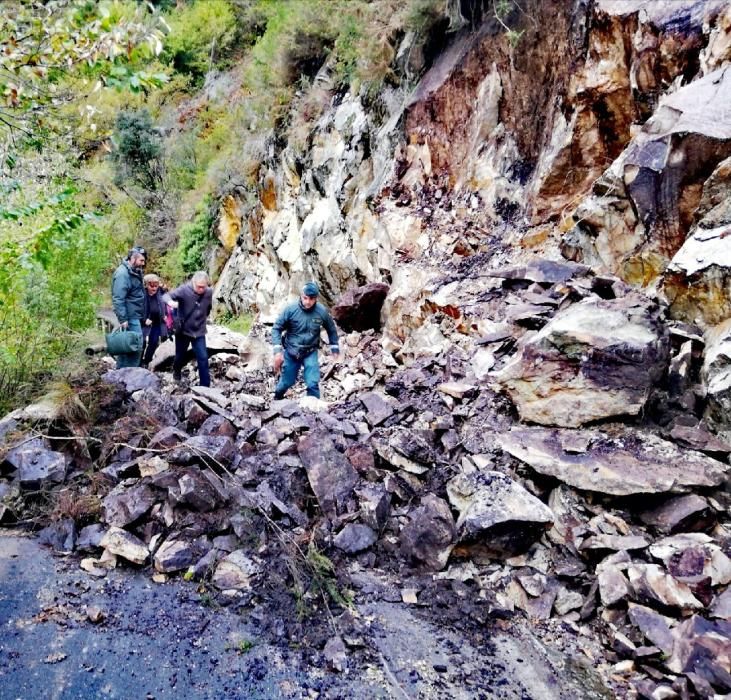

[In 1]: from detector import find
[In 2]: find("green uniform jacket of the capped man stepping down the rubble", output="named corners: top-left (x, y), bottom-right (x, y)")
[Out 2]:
top-left (272, 301), bottom-right (340, 359)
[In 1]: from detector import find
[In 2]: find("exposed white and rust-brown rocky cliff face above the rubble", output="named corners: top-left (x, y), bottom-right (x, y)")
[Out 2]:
top-left (218, 0), bottom-right (731, 330)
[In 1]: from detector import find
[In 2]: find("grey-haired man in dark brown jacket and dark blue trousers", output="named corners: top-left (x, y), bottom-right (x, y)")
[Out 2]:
top-left (163, 270), bottom-right (213, 386)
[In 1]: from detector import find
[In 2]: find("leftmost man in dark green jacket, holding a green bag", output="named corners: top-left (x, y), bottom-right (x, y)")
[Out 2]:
top-left (112, 246), bottom-right (147, 367)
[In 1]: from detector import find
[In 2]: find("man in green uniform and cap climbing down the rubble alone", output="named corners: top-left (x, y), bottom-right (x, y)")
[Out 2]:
top-left (272, 282), bottom-right (340, 399)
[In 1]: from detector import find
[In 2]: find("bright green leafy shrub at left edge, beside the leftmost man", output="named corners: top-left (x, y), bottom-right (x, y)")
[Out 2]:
top-left (0, 183), bottom-right (109, 410)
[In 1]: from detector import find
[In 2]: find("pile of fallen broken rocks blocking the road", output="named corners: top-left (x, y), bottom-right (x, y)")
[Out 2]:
top-left (0, 261), bottom-right (731, 698)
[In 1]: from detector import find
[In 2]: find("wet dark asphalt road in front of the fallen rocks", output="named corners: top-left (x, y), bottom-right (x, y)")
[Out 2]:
top-left (0, 530), bottom-right (611, 700)
